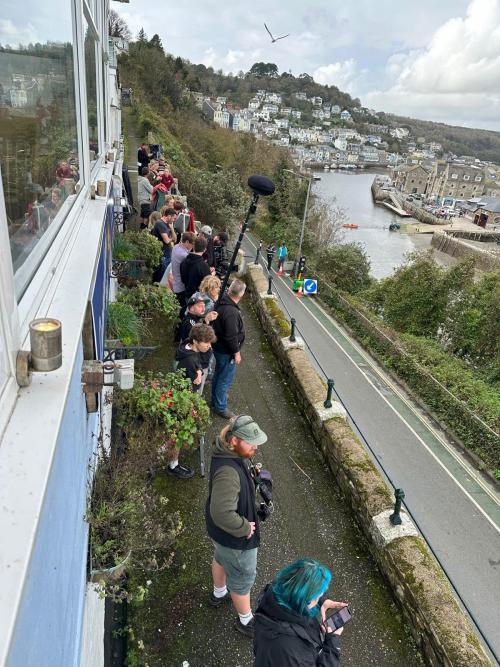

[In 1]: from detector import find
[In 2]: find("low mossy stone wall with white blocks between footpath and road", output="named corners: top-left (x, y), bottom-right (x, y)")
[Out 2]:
top-left (247, 265), bottom-right (492, 667)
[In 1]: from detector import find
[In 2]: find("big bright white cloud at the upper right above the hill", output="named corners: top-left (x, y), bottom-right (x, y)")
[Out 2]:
top-left (363, 0), bottom-right (500, 129)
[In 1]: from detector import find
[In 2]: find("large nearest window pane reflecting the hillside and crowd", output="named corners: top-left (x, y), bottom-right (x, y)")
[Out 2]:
top-left (0, 0), bottom-right (79, 297)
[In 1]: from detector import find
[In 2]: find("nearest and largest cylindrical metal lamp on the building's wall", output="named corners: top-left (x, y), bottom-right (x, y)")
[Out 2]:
top-left (16, 317), bottom-right (62, 387)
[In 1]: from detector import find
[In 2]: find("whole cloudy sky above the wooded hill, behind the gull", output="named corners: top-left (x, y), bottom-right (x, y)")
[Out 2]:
top-left (121, 0), bottom-right (500, 130)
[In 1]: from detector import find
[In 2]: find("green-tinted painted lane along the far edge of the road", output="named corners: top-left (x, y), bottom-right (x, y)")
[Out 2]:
top-left (283, 279), bottom-right (500, 528)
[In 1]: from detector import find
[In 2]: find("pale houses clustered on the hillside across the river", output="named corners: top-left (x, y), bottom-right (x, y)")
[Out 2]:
top-left (190, 90), bottom-right (500, 183)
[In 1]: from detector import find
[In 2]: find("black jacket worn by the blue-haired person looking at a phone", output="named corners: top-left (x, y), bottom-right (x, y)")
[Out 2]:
top-left (254, 585), bottom-right (340, 667)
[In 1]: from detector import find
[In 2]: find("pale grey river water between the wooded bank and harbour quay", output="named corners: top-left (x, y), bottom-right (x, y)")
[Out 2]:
top-left (313, 170), bottom-right (431, 278)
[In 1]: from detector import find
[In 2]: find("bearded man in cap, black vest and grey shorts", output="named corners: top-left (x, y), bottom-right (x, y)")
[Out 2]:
top-left (205, 415), bottom-right (267, 637)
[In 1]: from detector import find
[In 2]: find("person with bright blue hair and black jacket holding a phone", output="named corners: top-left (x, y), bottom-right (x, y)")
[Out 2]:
top-left (254, 558), bottom-right (347, 667)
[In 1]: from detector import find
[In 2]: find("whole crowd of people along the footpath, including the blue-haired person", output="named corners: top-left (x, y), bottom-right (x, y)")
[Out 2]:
top-left (138, 144), bottom-right (347, 667)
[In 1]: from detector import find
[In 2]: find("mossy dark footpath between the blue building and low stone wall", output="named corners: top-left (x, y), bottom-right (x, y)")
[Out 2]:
top-left (129, 297), bottom-right (422, 667)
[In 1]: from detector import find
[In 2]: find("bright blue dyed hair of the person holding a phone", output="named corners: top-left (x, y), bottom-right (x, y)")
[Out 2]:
top-left (272, 558), bottom-right (332, 616)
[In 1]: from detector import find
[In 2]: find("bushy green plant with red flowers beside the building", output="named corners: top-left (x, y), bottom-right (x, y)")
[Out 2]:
top-left (114, 372), bottom-right (210, 468)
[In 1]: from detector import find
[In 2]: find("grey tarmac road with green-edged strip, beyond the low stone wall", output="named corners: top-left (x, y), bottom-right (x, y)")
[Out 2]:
top-left (244, 238), bottom-right (500, 655)
